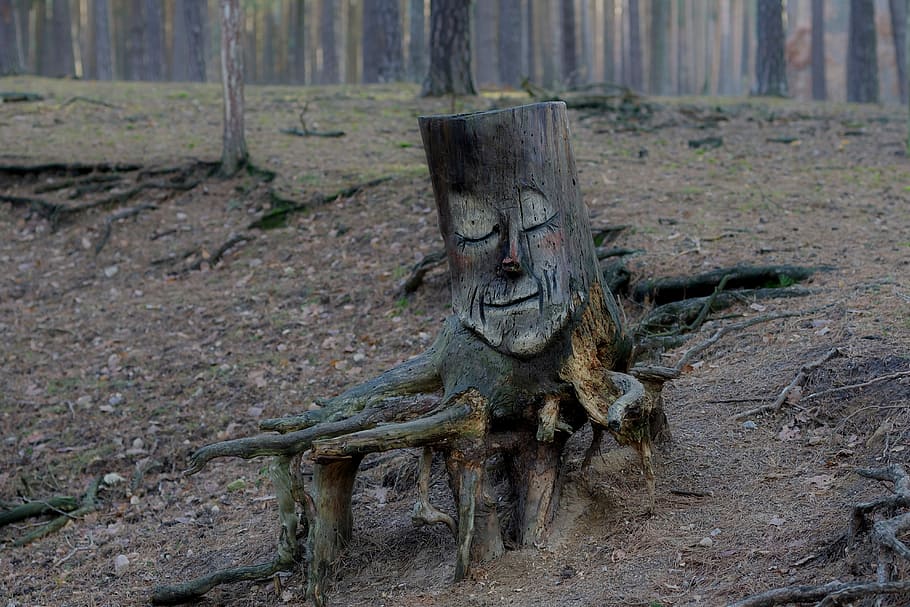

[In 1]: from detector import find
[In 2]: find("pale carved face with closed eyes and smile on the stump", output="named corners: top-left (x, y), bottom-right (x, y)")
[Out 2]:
top-left (446, 184), bottom-right (571, 356)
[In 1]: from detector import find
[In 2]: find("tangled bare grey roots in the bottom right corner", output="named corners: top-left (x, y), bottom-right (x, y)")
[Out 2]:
top-left (729, 464), bottom-right (910, 607)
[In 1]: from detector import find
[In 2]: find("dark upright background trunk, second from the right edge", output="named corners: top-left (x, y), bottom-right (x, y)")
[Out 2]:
top-left (847, 0), bottom-right (878, 103)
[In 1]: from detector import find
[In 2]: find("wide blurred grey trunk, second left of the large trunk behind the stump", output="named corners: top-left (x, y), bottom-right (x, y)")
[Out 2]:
top-left (363, 0), bottom-right (402, 83)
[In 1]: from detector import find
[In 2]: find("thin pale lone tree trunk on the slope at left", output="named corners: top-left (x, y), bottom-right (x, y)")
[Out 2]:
top-left (220, 0), bottom-right (248, 177)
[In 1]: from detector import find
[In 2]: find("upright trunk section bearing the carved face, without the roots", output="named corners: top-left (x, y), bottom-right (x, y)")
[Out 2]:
top-left (420, 102), bottom-right (598, 358)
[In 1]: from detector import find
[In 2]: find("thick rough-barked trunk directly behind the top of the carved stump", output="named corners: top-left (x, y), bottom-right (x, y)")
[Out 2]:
top-left (421, 0), bottom-right (477, 97)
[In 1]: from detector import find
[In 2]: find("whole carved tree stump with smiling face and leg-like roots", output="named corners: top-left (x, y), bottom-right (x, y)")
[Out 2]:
top-left (155, 102), bottom-right (664, 605)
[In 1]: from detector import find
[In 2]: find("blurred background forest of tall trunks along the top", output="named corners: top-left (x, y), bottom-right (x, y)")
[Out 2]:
top-left (0, 0), bottom-right (907, 103)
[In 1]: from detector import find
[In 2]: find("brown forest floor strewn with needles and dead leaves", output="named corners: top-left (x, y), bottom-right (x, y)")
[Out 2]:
top-left (0, 78), bottom-right (910, 607)
